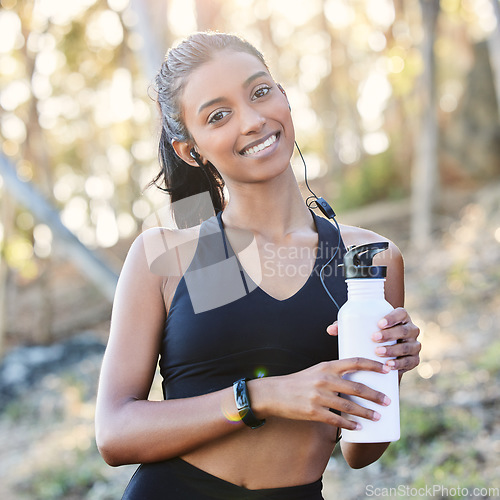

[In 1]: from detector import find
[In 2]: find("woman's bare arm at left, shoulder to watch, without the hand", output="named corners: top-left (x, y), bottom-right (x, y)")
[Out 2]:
top-left (96, 232), bottom-right (242, 466)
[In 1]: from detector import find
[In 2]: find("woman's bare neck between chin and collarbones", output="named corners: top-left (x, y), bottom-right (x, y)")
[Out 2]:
top-left (223, 166), bottom-right (315, 240)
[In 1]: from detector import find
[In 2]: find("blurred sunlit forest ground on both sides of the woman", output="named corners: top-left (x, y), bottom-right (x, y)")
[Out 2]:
top-left (0, 185), bottom-right (500, 500)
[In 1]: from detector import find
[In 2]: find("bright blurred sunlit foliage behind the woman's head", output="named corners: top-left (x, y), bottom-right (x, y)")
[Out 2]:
top-left (0, 0), bottom-right (492, 280)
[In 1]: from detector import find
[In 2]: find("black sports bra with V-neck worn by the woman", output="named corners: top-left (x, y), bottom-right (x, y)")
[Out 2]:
top-left (160, 211), bottom-right (347, 399)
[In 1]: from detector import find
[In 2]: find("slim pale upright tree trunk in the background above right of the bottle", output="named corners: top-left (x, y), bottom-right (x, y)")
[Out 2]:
top-left (411, 0), bottom-right (439, 249)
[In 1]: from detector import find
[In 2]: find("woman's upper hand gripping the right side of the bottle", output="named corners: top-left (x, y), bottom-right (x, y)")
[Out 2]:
top-left (326, 307), bottom-right (422, 374)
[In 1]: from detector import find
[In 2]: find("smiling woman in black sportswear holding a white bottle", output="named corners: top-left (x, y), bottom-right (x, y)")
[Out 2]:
top-left (96, 33), bottom-right (420, 500)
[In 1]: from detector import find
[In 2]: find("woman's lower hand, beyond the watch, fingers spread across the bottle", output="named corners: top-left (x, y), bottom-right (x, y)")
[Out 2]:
top-left (248, 358), bottom-right (390, 430)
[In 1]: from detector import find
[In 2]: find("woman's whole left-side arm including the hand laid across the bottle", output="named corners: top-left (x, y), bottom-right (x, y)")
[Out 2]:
top-left (96, 229), bottom-right (412, 465)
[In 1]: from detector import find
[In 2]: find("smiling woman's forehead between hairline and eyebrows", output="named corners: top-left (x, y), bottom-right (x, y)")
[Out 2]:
top-left (182, 49), bottom-right (270, 111)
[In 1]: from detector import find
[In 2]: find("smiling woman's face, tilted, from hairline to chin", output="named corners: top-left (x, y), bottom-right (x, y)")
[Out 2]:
top-left (181, 50), bottom-right (295, 187)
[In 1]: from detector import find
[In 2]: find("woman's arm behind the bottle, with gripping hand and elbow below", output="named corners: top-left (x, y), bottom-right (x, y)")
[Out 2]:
top-left (328, 238), bottom-right (420, 469)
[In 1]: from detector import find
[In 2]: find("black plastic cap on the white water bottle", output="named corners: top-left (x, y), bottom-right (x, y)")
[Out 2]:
top-left (344, 241), bottom-right (389, 280)
